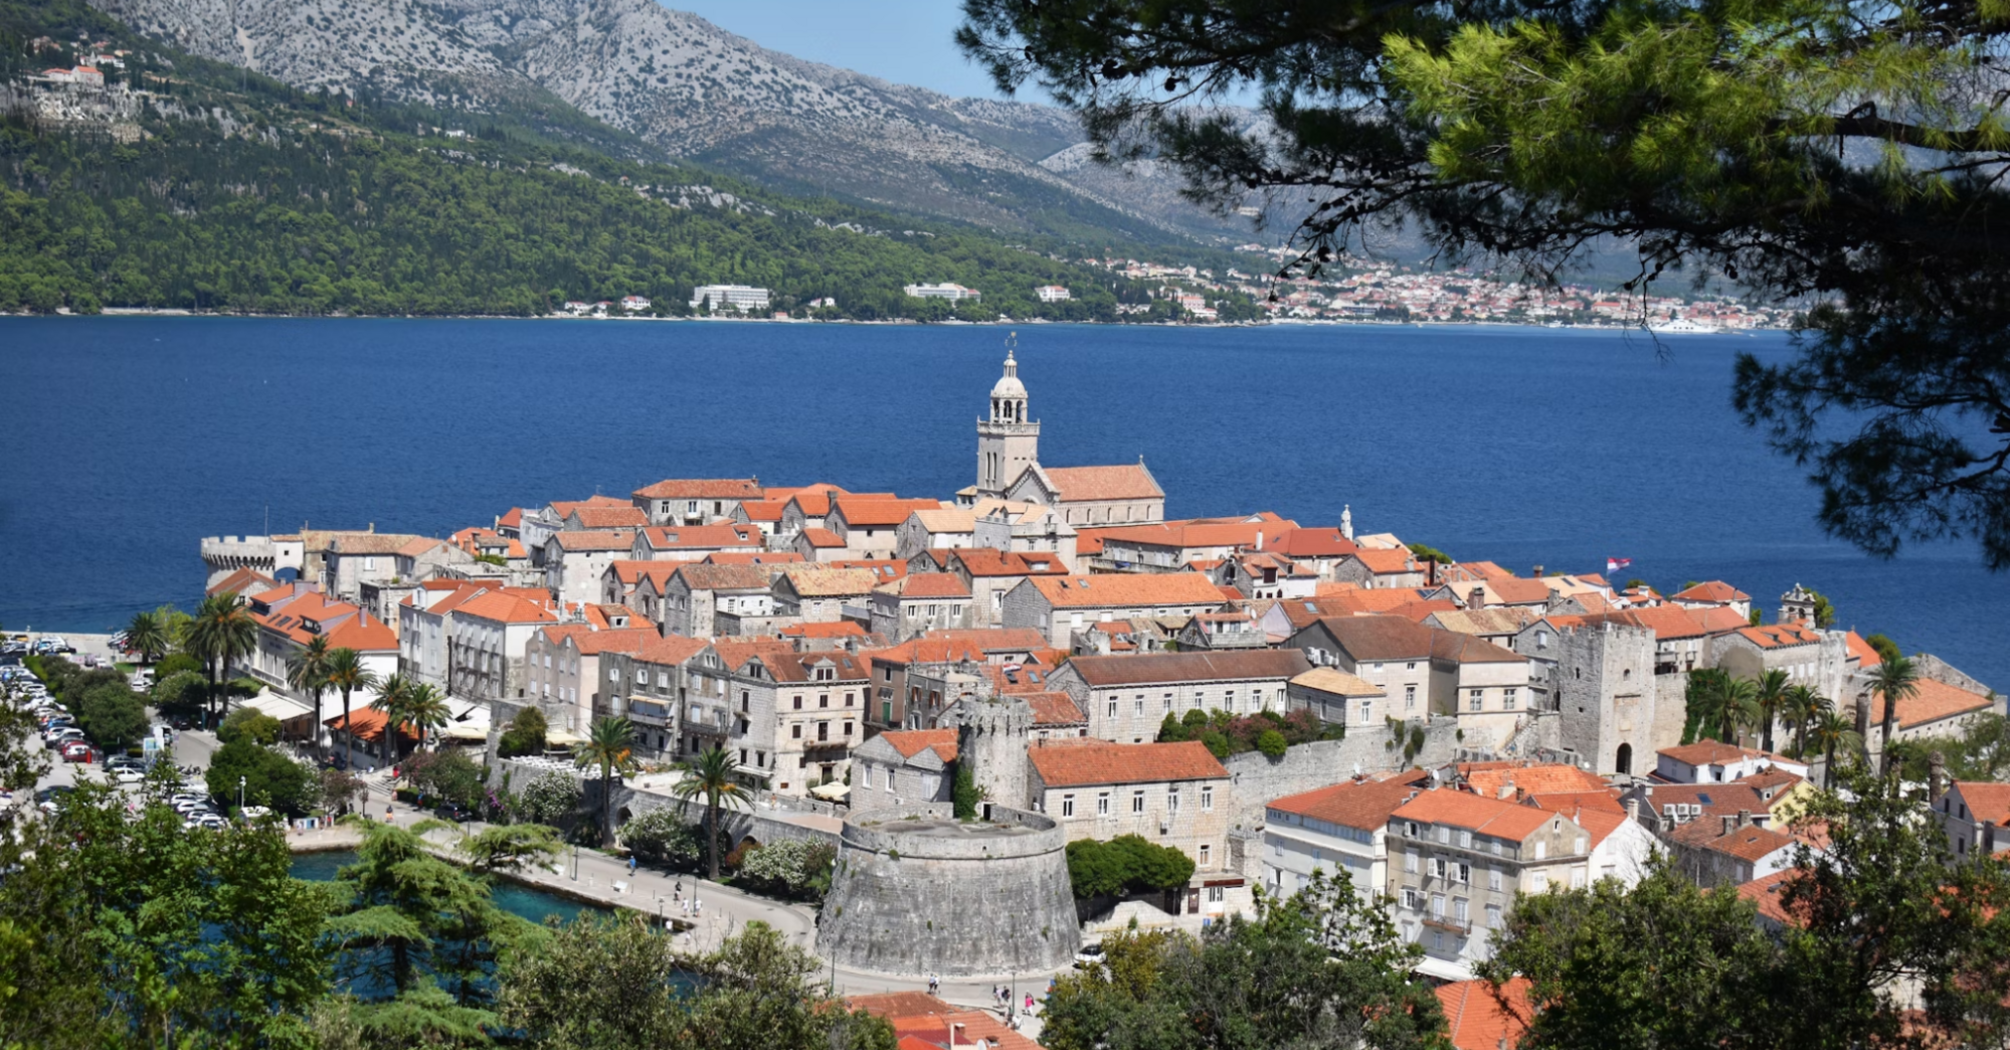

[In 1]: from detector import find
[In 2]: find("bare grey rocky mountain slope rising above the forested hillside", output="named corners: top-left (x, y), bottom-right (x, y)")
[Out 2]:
top-left (92, 0), bottom-right (1250, 243)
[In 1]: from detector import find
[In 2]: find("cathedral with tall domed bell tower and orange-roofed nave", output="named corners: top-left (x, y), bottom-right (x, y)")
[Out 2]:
top-left (957, 350), bottom-right (1166, 525)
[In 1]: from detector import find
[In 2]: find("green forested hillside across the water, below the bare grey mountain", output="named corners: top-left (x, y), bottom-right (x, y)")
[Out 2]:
top-left (0, 0), bottom-right (1238, 320)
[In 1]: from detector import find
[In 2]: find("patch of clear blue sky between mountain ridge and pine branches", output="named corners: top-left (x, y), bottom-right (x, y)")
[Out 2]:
top-left (665, 0), bottom-right (1013, 103)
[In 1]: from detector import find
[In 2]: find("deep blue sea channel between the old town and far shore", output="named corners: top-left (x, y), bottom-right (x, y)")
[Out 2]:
top-left (0, 318), bottom-right (2010, 690)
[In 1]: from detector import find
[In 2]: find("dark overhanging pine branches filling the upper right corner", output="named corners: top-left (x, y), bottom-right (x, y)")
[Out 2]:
top-left (957, 0), bottom-right (2010, 569)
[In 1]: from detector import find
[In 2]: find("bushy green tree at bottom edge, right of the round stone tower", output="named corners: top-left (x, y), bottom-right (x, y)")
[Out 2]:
top-left (1041, 875), bottom-right (1451, 1050)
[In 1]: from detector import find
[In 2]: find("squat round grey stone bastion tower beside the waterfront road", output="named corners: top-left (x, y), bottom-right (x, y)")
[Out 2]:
top-left (816, 803), bottom-right (1081, 976)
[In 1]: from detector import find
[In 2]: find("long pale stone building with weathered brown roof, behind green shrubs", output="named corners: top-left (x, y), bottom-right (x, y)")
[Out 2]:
top-left (1047, 650), bottom-right (1313, 744)
